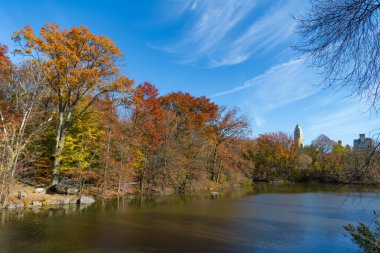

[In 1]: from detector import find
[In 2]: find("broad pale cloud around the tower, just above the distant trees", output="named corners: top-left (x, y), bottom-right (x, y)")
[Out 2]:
top-left (229, 56), bottom-right (380, 144)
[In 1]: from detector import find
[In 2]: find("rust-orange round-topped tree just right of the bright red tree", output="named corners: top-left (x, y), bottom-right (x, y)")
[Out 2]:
top-left (161, 92), bottom-right (218, 192)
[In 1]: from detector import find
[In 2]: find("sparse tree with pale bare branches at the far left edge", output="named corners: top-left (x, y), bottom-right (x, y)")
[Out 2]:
top-left (0, 61), bottom-right (52, 205)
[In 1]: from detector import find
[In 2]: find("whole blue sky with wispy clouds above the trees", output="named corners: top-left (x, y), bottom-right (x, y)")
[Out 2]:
top-left (0, 0), bottom-right (380, 145)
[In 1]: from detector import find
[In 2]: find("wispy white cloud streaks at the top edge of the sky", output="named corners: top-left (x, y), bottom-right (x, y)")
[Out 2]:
top-left (155, 0), bottom-right (303, 67)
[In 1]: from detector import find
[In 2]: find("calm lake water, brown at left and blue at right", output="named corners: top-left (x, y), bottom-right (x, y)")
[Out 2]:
top-left (0, 184), bottom-right (380, 253)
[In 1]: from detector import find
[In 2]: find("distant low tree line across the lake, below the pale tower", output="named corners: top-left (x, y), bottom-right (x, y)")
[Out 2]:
top-left (242, 132), bottom-right (380, 184)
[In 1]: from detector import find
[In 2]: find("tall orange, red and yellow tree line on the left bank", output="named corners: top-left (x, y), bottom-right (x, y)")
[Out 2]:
top-left (0, 24), bottom-right (254, 206)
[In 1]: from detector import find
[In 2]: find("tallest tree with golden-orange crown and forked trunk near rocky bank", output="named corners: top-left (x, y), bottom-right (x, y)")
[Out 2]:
top-left (13, 24), bottom-right (133, 187)
